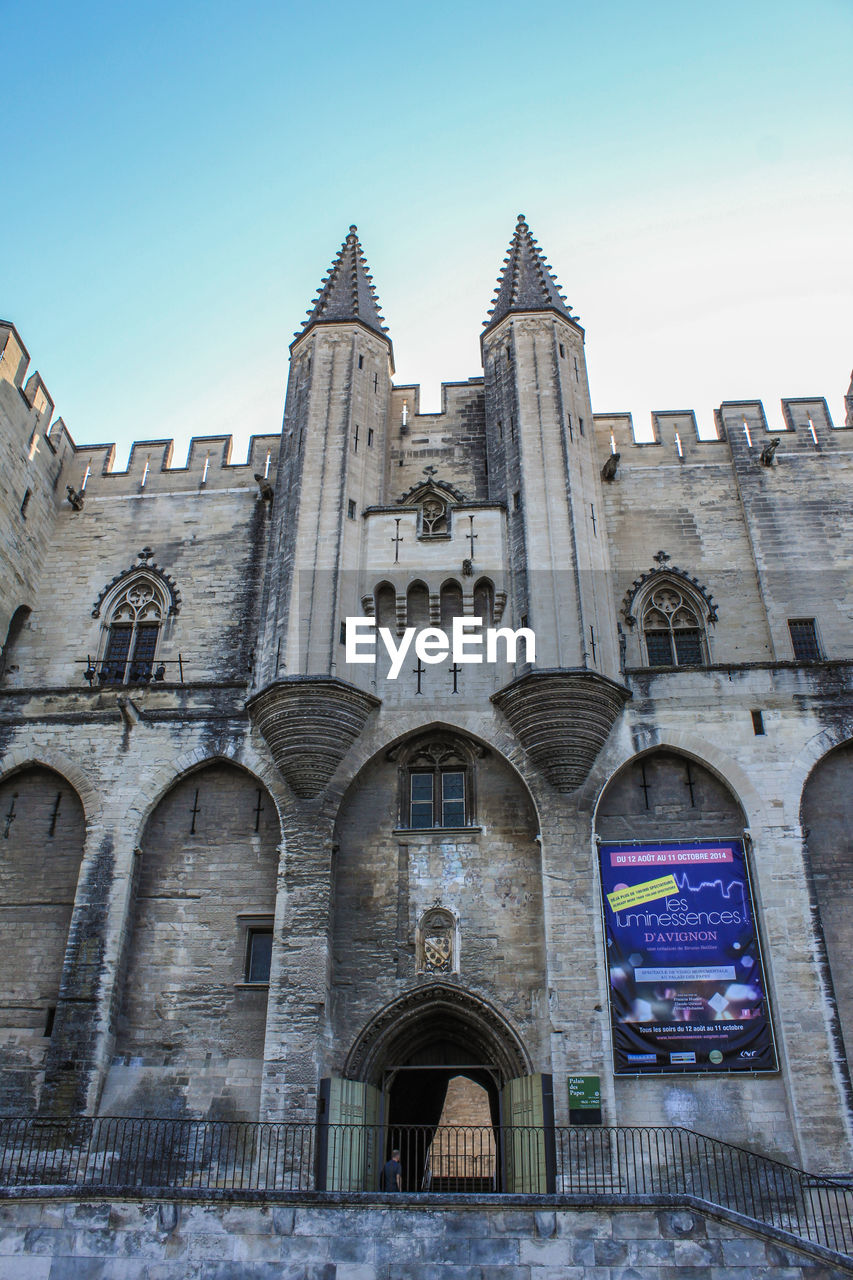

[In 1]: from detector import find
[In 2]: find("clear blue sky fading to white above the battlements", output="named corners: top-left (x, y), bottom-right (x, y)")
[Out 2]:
top-left (0, 0), bottom-right (853, 466)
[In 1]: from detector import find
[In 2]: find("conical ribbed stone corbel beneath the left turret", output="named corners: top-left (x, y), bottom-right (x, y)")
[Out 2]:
top-left (246, 676), bottom-right (380, 800)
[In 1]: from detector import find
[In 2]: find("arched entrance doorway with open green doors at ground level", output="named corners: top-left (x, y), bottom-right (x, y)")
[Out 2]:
top-left (321, 982), bottom-right (553, 1192)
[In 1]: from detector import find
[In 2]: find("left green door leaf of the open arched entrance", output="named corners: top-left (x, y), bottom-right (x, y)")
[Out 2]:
top-left (316, 1076), bottom-right (382, 1192)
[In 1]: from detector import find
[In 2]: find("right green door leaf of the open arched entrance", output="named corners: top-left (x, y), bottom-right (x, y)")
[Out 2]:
top-left (501, 1074), bottom-right (557, 1196)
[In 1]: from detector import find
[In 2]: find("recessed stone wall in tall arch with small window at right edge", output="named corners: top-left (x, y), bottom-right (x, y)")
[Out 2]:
top-left (101, 764), bottom-right (280, 1119)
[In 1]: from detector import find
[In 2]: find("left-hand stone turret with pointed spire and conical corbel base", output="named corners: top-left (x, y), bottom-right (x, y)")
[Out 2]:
top-left (250, 227), bottom-right (393, 797)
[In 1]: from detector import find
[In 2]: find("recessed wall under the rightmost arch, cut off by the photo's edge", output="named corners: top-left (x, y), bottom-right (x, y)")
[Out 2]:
top-left (800, 737), bottom-right (853, 1069)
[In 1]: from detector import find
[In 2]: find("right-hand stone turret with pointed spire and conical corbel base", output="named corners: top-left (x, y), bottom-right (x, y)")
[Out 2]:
top-left (482, 215), bottom-right (626, 791)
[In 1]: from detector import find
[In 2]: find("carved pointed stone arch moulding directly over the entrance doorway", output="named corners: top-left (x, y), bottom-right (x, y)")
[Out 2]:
top-left (343, 982), bottom-right (533, 1084)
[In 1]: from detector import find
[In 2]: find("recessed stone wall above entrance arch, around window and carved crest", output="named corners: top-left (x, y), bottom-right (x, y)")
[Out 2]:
top-left (329, 735), bottom-right (546, 1071)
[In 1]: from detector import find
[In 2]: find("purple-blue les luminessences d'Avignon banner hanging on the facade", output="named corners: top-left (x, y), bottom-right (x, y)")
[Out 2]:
top-left (599, 840), bottom-right (776, 1075)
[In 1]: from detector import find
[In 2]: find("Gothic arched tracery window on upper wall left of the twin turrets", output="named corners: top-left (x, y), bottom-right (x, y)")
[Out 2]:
top-left (99, 575), bottom-right (169, 685)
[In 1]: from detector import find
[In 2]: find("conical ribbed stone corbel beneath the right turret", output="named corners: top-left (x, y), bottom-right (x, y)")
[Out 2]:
top-left (492, 669), bottom-right (631, 794)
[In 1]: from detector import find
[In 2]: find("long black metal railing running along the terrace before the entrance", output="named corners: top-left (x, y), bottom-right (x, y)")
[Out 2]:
top-left (0, 1117), bottom-right (853, 1256)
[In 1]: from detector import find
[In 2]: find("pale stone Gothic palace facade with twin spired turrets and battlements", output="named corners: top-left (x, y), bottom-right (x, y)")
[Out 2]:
top-left (0, 219), bottom-right (853, 1170)
